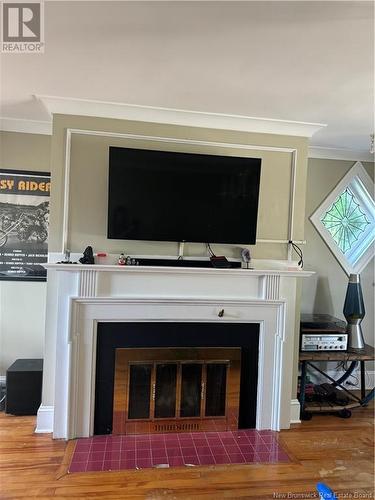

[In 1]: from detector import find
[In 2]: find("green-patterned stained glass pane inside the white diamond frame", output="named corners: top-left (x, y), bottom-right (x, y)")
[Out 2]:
top-left (320, 188), bottom-right (370, 254)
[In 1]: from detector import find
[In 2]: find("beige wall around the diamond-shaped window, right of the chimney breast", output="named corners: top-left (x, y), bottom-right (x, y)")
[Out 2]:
top-left (301, 159), bottom-right (374, 345)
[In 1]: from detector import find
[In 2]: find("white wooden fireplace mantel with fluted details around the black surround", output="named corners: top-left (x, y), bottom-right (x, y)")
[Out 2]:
top-left (37, 264), bottom-right (313, 439)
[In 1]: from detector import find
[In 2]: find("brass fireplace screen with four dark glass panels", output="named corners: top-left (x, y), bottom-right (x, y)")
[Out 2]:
top-left (112, 347), bottom-right (241, 434)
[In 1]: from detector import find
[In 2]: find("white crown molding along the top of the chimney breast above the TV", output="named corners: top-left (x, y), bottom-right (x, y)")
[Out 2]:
top-left (34, 95), bottom-right (326, 137)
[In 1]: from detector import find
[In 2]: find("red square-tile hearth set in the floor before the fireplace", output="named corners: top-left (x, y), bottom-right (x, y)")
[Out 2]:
top-left (69, 429), bottom-right (289, 472)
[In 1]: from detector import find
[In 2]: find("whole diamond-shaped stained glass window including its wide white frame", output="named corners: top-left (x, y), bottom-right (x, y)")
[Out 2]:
top-left (310, 162), bottom-right (375, 274)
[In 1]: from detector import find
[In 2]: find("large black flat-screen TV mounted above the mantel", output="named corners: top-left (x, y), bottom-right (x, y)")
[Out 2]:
top-left (108, 147), bottom-right (261, 244)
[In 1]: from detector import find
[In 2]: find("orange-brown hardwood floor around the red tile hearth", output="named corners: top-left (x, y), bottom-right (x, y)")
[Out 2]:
top-left (0, 406), bottom-right (374, 500)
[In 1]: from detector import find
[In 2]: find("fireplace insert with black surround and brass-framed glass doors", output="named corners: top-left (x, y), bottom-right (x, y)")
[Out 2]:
top-left (94, 322), bottom-right (259, 434)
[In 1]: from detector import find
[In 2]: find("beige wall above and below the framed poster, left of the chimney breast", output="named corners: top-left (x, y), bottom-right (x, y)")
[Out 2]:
top-left (0, 132), bottom-right (51, 376)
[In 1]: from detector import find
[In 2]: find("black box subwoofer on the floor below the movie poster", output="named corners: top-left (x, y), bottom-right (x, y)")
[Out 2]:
top-left (5, 359), bottom-right (43, 415)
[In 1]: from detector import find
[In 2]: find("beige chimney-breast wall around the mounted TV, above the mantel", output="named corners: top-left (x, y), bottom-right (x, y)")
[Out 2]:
top-left (50, 115), bottom-right (307, 258)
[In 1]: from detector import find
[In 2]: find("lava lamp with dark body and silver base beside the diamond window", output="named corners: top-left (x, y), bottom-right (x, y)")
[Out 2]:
top-left (343, 274), bottom-right (365, 350)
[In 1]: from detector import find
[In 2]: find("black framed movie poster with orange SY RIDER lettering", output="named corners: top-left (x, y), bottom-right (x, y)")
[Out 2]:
top-left (0, 170), bottom-right (51, 281)
